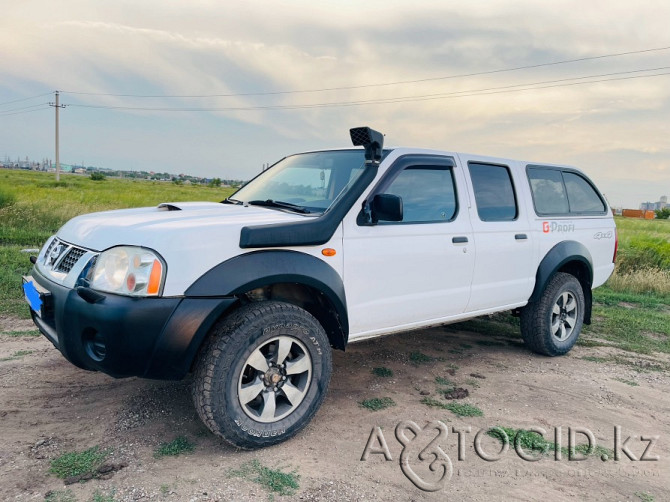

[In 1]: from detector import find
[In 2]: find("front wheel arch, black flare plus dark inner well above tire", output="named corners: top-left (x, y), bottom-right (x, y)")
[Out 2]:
top-left (186, 250), bottom-right (349, 350)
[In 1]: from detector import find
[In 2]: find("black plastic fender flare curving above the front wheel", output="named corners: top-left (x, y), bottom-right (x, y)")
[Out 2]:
top-left (185, 249), bottom-right (349, 349)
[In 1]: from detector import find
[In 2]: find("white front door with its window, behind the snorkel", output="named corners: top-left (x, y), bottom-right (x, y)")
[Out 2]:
top-left (343, 155), bottom-right (475, 340)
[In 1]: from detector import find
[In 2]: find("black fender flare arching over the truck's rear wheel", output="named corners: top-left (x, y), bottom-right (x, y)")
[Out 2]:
top-left (528, 241), bottom-right (593, 324)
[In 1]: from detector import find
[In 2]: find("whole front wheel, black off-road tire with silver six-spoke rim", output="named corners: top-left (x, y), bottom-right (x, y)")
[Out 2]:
top-left (193, 301), bottom-right (332, 449)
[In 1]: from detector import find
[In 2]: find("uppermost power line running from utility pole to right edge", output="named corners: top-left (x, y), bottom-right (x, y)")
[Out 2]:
top-left (62, 46), bottom-right (670, 98)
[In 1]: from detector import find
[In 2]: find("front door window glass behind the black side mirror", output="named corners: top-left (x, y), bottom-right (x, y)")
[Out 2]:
top-left (384, 166), bottom-right (456, 223)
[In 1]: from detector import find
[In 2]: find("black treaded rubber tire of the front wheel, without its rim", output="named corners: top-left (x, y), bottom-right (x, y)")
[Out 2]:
top-left (192, 301), bottom-right (332, 449)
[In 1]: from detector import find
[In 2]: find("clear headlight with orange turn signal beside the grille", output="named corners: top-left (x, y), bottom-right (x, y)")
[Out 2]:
top-left (90, 246), bottom-right (165, 296)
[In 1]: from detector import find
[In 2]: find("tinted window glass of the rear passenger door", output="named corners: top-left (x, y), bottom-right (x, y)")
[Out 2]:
top-left (468, 163), bottom-right (517, 221)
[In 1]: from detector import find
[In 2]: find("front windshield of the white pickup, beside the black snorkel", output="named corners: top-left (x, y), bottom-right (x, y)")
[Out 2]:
top-left (228, 150), bottom-right (365, 213)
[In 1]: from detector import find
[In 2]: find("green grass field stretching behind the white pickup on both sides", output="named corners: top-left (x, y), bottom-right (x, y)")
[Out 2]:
top-left (0, 170), bottom-right (670, 353)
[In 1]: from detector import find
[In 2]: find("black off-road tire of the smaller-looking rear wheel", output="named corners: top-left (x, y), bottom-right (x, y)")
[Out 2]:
top-left (521, 272), bottom-right (586, 356)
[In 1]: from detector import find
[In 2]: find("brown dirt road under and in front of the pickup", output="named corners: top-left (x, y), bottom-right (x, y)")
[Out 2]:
top-left (0, 318), bottom-right (670, 501)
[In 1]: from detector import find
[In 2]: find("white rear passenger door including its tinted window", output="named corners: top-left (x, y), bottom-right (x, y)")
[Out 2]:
top-left (461, 157), bottom-right (535, 312)
